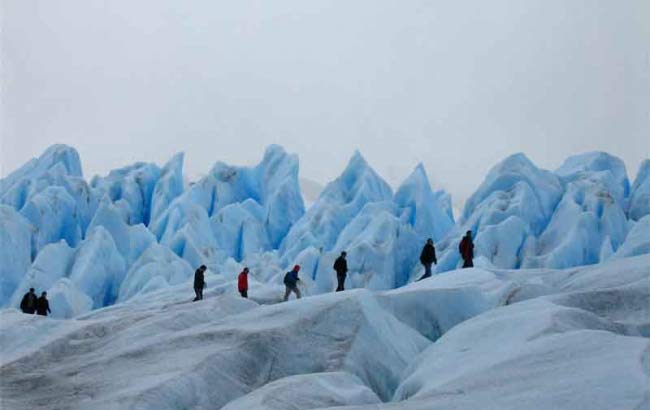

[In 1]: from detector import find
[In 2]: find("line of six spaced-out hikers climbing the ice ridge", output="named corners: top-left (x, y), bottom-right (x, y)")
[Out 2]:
top-left (194, 231), bottom-right (474, 302)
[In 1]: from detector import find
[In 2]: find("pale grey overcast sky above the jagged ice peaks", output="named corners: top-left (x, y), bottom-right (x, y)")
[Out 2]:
top-left (0, 0), bottom-right (650, 205)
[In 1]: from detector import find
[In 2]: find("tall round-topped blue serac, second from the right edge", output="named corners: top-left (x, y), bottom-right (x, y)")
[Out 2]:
top-left (523, 152), bottom-right (629, 268)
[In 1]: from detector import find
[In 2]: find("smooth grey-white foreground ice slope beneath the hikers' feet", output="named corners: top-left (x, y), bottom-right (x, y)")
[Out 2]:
top-left (0, 255), bottom-right (650, 410)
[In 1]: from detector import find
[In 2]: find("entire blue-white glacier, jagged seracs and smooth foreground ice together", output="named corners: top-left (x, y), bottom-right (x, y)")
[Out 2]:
top-left (0, 145), bottom-right (650, 410)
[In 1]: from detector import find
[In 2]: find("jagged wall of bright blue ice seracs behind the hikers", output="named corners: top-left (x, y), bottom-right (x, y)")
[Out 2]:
top-left (0, 145), bottom-right (650, 317)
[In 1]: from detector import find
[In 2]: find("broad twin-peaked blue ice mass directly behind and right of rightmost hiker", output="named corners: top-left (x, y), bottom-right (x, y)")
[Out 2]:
top-left (430, 152), bottom-right (641, 272)
